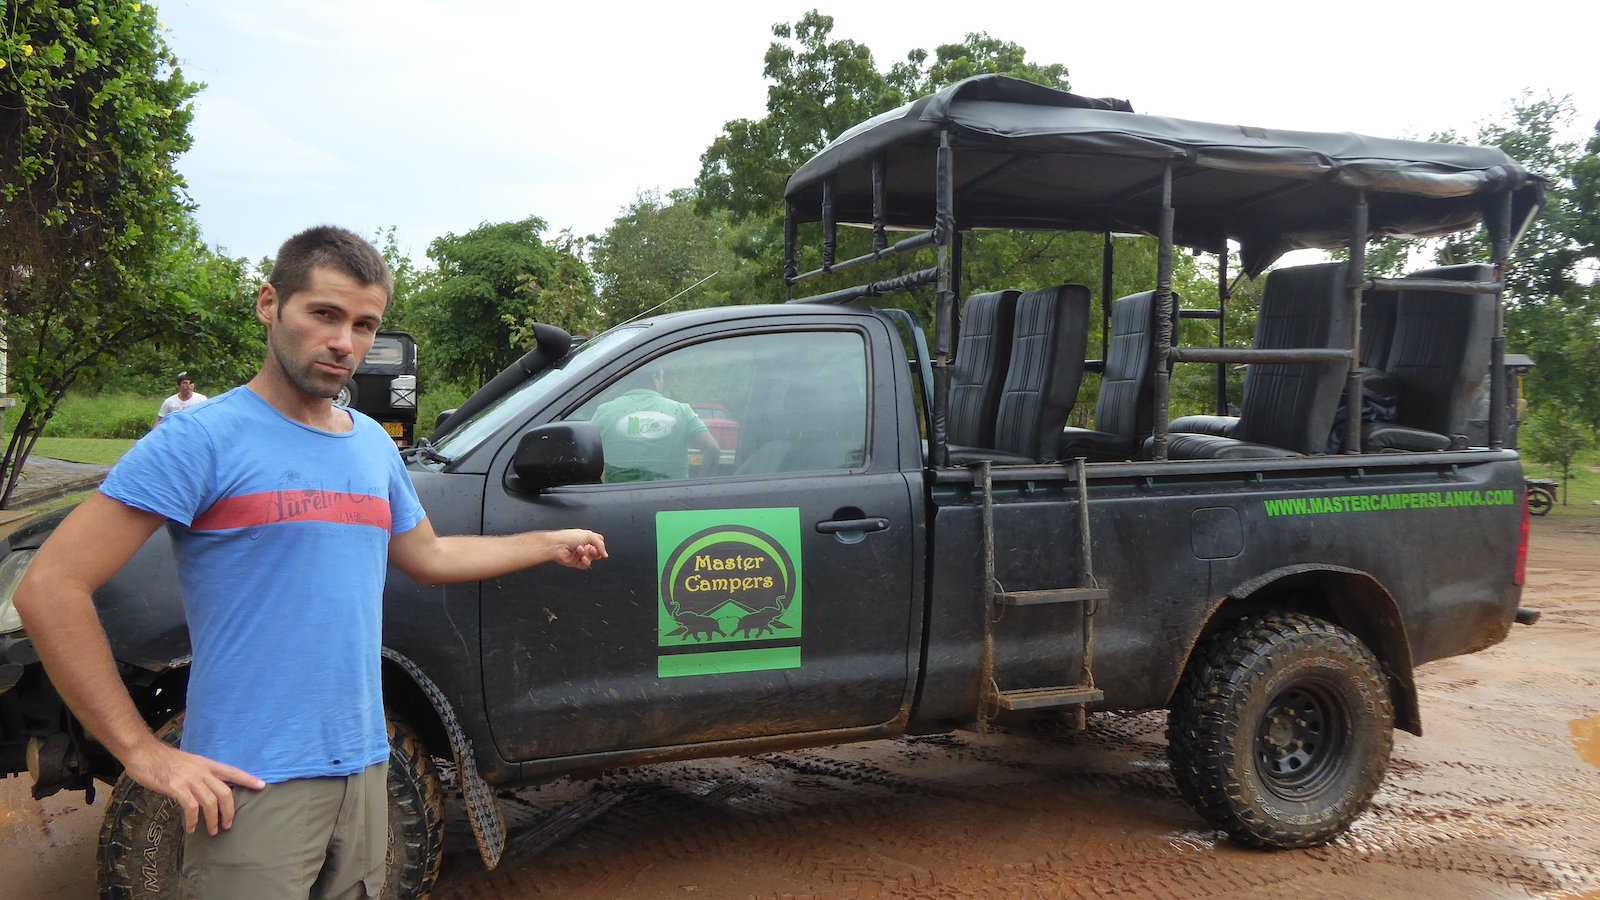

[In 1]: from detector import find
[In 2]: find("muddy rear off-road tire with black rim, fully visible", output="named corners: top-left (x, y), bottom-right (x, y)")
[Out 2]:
top-left (1166, 613), bottom-right (1394, 847)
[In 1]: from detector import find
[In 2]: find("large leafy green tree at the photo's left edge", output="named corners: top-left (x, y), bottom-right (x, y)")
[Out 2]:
top-left (0, 0), bottom-right (237, 506)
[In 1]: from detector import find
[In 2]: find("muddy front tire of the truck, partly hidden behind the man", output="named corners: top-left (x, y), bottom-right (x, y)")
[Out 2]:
top-left (98, 714), bottom-right (445, 900)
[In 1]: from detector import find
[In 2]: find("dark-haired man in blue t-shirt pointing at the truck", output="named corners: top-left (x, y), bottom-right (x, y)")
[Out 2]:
top-left (16, 227), bottom-right (606, 898)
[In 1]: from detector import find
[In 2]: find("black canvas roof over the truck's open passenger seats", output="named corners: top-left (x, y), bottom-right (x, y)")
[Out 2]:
top-left (784, 75), bottom-right (1542, 274)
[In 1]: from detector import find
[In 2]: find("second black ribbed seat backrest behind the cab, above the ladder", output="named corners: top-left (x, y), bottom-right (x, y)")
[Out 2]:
top-left (995, 285), bottom-right (1090, 461)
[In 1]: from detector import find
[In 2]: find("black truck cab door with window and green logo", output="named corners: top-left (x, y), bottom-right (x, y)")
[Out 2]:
top-left (482, 317), bottom-right (914, 761)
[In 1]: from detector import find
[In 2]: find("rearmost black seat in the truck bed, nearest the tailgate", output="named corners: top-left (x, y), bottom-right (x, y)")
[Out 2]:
top-left (1362, 264), bottom-right (1494, 450)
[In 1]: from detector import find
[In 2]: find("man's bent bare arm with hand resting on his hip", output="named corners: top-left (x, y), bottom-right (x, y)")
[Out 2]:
top-left (16, 493), bottom-right (264, 834)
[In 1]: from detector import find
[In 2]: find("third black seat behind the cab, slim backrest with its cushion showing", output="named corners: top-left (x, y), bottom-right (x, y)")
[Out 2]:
top-left (1056, 291), bottom-right (1178, 461)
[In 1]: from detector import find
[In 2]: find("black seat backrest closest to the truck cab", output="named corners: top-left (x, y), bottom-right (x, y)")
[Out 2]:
top-left (944, 290), bottom-right (1022, 447)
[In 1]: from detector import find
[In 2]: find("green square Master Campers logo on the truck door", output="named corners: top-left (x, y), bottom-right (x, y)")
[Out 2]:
top-left (656, 508), bottom-right (802, 677)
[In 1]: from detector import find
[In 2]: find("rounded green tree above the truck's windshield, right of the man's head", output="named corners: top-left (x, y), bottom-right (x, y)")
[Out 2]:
top-left (416, 216), bottom-right (598, 386)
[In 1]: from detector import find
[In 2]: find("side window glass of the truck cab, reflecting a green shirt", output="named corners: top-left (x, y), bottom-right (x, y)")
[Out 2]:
top-left (568, 331), bottom-right (867, 482)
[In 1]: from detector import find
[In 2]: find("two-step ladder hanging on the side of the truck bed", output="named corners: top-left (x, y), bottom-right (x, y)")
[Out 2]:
top-left (976, 458), bottom-right (1110, 730)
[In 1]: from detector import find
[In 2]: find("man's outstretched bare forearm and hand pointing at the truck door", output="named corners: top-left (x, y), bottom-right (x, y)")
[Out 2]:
top-left (389, 519), bottom-right (606, 585)
